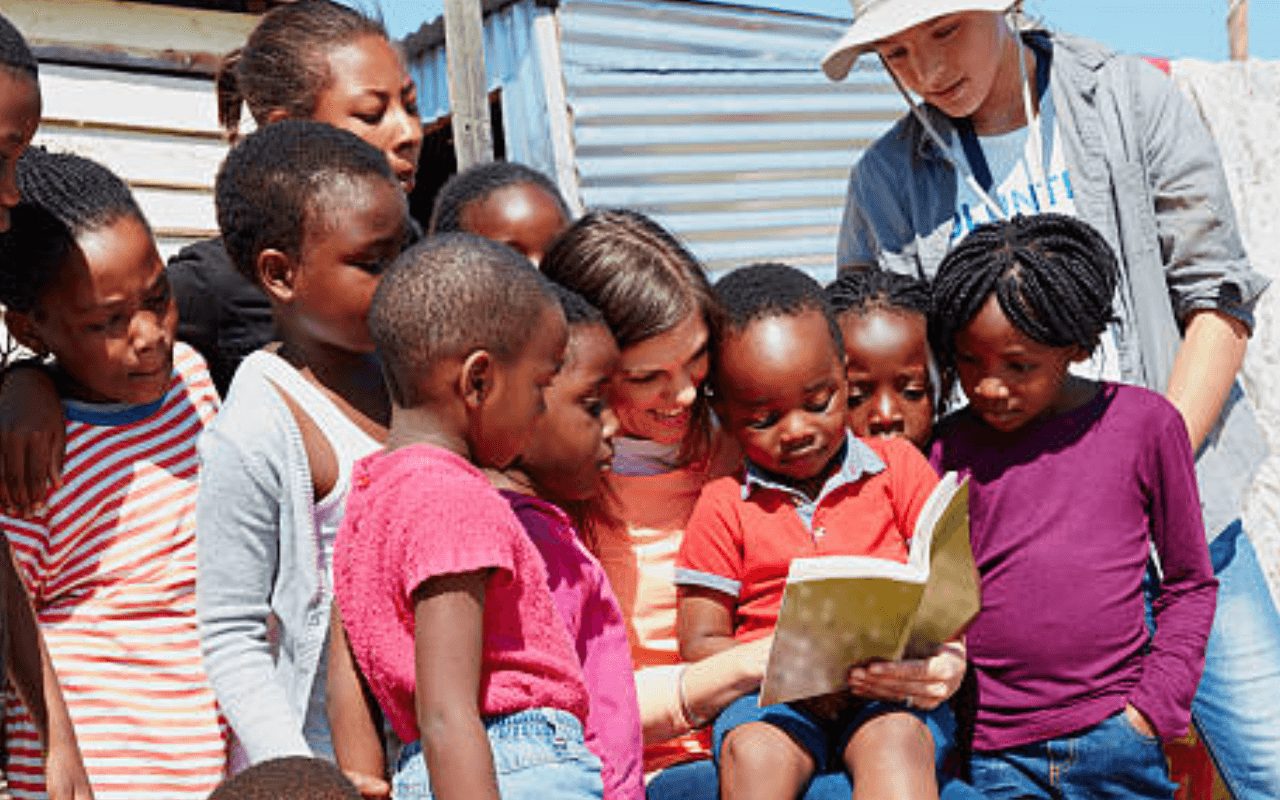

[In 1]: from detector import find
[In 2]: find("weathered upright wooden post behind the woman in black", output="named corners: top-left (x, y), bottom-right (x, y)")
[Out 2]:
top-left (444, 0), bottom-right (493, 172)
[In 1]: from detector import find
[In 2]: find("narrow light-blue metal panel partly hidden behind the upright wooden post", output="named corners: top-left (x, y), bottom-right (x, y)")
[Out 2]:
top-left (410, 0), bottom-right (559, 180)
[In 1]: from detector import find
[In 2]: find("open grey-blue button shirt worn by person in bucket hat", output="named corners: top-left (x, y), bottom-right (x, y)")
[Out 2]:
top-left (837, 32), bottom-right (1268, 539)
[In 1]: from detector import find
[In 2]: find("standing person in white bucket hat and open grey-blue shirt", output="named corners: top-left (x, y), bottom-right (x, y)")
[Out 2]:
top-left (823, 0), bottom-right (1280, 800)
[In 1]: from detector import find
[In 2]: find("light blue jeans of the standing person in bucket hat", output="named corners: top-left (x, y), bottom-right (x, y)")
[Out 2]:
top-left (1192, 521), bottom-right (1280, 800)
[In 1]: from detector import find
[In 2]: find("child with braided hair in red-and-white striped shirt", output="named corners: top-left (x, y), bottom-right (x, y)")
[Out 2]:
top-left (0, 150), bottom-right (225, 800)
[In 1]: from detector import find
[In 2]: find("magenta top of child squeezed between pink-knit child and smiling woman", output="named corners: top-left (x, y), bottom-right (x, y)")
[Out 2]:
top-left (502, 492), bottom-right (644, 800)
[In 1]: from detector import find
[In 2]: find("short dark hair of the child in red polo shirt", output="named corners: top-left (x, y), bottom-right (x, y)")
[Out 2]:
top-left (714, 261), bottom-right (845, 353)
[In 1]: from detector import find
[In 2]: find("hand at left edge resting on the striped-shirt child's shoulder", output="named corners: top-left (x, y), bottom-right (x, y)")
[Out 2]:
top-left (0, 364), bottom-right (67, 516)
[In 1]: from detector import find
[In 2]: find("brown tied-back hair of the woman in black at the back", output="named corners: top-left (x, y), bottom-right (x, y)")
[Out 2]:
top-left (215, 0), bottom-right (388, 141)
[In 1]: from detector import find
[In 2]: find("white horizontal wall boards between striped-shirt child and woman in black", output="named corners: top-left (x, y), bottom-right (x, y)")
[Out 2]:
top-left (36, 64), bottom-right (227, 259)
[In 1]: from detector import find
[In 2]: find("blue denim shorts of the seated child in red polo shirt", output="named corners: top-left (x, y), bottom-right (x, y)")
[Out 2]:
top-left (712, 692), bottom-right (955, 773)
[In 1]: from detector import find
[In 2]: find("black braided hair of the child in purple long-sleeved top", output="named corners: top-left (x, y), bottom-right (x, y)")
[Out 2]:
top-left (929, 214), bottom-right (1120, 366)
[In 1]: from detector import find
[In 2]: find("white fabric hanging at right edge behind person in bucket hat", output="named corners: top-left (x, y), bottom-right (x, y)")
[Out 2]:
top-left (1171, 60), bottom-right (1280, 604)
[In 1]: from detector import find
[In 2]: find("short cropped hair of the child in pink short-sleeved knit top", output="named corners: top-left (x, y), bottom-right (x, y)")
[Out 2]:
top-left (369, 233), bottom-right (557, 408)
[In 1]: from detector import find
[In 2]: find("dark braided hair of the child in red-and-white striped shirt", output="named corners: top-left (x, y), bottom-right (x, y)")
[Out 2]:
top-left (0, 147), bottom-right (150, 314)
